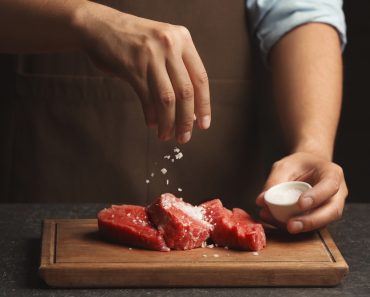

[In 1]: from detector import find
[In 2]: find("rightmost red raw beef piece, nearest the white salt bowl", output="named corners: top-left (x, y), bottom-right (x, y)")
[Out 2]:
top-left (200, 199), bottom-right (266, 251)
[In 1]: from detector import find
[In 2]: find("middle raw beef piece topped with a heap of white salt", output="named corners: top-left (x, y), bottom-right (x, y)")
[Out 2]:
top-left (148, 194), bottom-right (212, 250)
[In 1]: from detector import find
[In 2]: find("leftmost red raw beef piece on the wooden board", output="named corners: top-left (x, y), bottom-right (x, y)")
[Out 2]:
top-left (98, 205), bottom-right (170, 251)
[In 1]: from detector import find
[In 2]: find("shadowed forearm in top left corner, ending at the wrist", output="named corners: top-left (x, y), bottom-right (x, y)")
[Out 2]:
top-left (0, 0), bottom-right (86, 53)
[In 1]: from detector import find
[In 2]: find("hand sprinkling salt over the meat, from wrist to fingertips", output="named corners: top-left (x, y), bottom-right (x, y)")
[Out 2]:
top-left (79, 1), bottom-right (211, 144)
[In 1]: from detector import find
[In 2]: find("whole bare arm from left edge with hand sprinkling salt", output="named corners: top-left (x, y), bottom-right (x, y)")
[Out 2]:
top-left (0, 0), bottom-right (211, 144)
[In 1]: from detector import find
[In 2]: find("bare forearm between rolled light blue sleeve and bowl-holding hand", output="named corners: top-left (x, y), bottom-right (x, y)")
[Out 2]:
top-left (270, 23), bottom-right (342, 160)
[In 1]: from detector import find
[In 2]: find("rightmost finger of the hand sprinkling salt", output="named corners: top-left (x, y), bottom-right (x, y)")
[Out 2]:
top-left (183, 34), bottom-right (211, 129)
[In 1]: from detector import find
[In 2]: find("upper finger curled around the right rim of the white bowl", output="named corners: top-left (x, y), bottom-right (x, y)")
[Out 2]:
top-left (298, 166), bottom-right (343, 210)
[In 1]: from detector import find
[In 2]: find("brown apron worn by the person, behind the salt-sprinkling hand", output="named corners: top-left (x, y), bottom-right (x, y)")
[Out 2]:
top-left (3, 0), bottom-right (262, 207)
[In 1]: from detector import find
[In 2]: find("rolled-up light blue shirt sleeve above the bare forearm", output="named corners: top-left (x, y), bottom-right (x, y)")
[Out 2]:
top-left (246, 0), bottom-right (347, 58)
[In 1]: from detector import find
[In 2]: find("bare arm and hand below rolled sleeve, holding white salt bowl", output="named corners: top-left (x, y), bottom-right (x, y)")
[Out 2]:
top-left (257, 23), bottom-right (347, 233)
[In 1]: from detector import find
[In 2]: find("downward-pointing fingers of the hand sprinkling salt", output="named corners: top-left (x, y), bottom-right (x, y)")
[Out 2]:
top-left (142, 27), bottom-right (211, 144)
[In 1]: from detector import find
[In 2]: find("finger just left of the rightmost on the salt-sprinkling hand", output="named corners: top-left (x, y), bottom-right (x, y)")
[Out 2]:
top-left (167, 57), bottom-right (194, 144)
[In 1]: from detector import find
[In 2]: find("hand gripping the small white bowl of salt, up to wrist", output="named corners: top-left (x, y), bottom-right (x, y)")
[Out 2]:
top-left (256, 152), bottom-right (348, 233)
